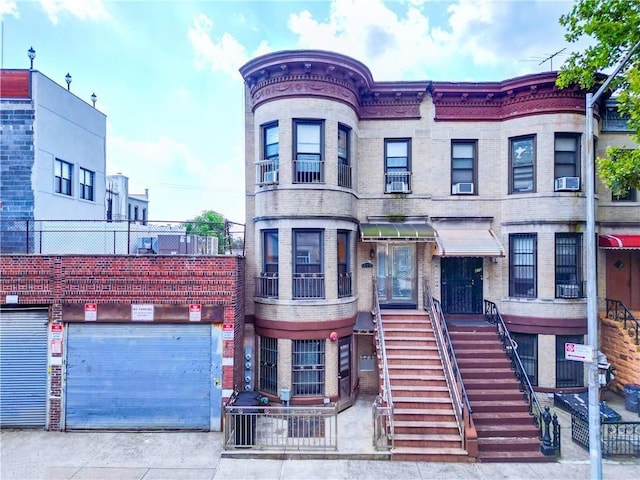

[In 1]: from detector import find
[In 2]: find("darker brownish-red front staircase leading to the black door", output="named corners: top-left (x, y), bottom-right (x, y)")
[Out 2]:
top-left (448, 321), bottom-right (556, 462)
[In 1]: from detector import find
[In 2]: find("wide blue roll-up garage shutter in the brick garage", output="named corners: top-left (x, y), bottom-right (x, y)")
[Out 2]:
top-left (65, 323), bottom-right (212, 430)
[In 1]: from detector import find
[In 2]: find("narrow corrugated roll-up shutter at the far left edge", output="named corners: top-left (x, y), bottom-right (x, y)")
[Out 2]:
top-left (0, 310), bottom-right (49, 427)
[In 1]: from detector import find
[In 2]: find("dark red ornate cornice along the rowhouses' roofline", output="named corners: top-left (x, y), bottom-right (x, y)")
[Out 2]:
top-left (240, 50), bottom-right (598, 121)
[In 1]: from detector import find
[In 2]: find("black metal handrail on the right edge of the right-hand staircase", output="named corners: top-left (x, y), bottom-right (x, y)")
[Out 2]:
top-left (484, 300), bottom-right (560, 455)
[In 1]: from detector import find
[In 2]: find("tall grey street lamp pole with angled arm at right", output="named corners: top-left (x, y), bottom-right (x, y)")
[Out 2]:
top-left (585, 41), bottom-right (640, 480)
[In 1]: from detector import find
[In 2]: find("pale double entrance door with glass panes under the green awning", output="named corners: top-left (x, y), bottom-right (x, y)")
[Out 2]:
top-left (378, 244), bottom-right (417, 306)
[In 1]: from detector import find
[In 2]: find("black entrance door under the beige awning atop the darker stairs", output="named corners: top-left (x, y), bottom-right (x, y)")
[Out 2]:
top-left (441, 257), bottom-right (482, 315)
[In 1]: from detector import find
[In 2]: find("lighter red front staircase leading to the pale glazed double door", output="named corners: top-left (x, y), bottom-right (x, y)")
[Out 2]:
top-left (379, 310), bottom-right (473, 462)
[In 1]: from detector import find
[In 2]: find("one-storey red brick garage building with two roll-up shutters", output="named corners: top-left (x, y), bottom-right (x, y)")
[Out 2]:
top-left (0, 255), bottom-right (244, 430)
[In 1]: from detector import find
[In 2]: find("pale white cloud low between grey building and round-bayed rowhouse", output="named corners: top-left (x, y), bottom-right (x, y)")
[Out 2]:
top-left (107, 132), bottom-right (244, 223)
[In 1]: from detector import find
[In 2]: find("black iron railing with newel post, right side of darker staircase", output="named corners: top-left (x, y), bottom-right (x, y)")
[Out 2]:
top-left (484, 300), bottom-right (561, 456)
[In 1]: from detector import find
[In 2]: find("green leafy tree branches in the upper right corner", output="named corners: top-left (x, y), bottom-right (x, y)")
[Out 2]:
top-left (558, 0), bottom-right (640, 196)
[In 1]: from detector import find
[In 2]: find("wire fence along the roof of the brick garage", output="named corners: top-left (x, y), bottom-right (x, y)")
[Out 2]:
top-left (0, 219), bottom-right (244, 255)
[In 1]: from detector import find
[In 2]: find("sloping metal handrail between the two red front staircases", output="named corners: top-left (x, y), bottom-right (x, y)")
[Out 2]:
top-left (423, 279), bottom-right (473, 442)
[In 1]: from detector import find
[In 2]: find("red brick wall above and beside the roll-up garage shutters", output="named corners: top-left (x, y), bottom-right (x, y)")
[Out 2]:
top-left (0, 255), bottom-right (244, 430)
